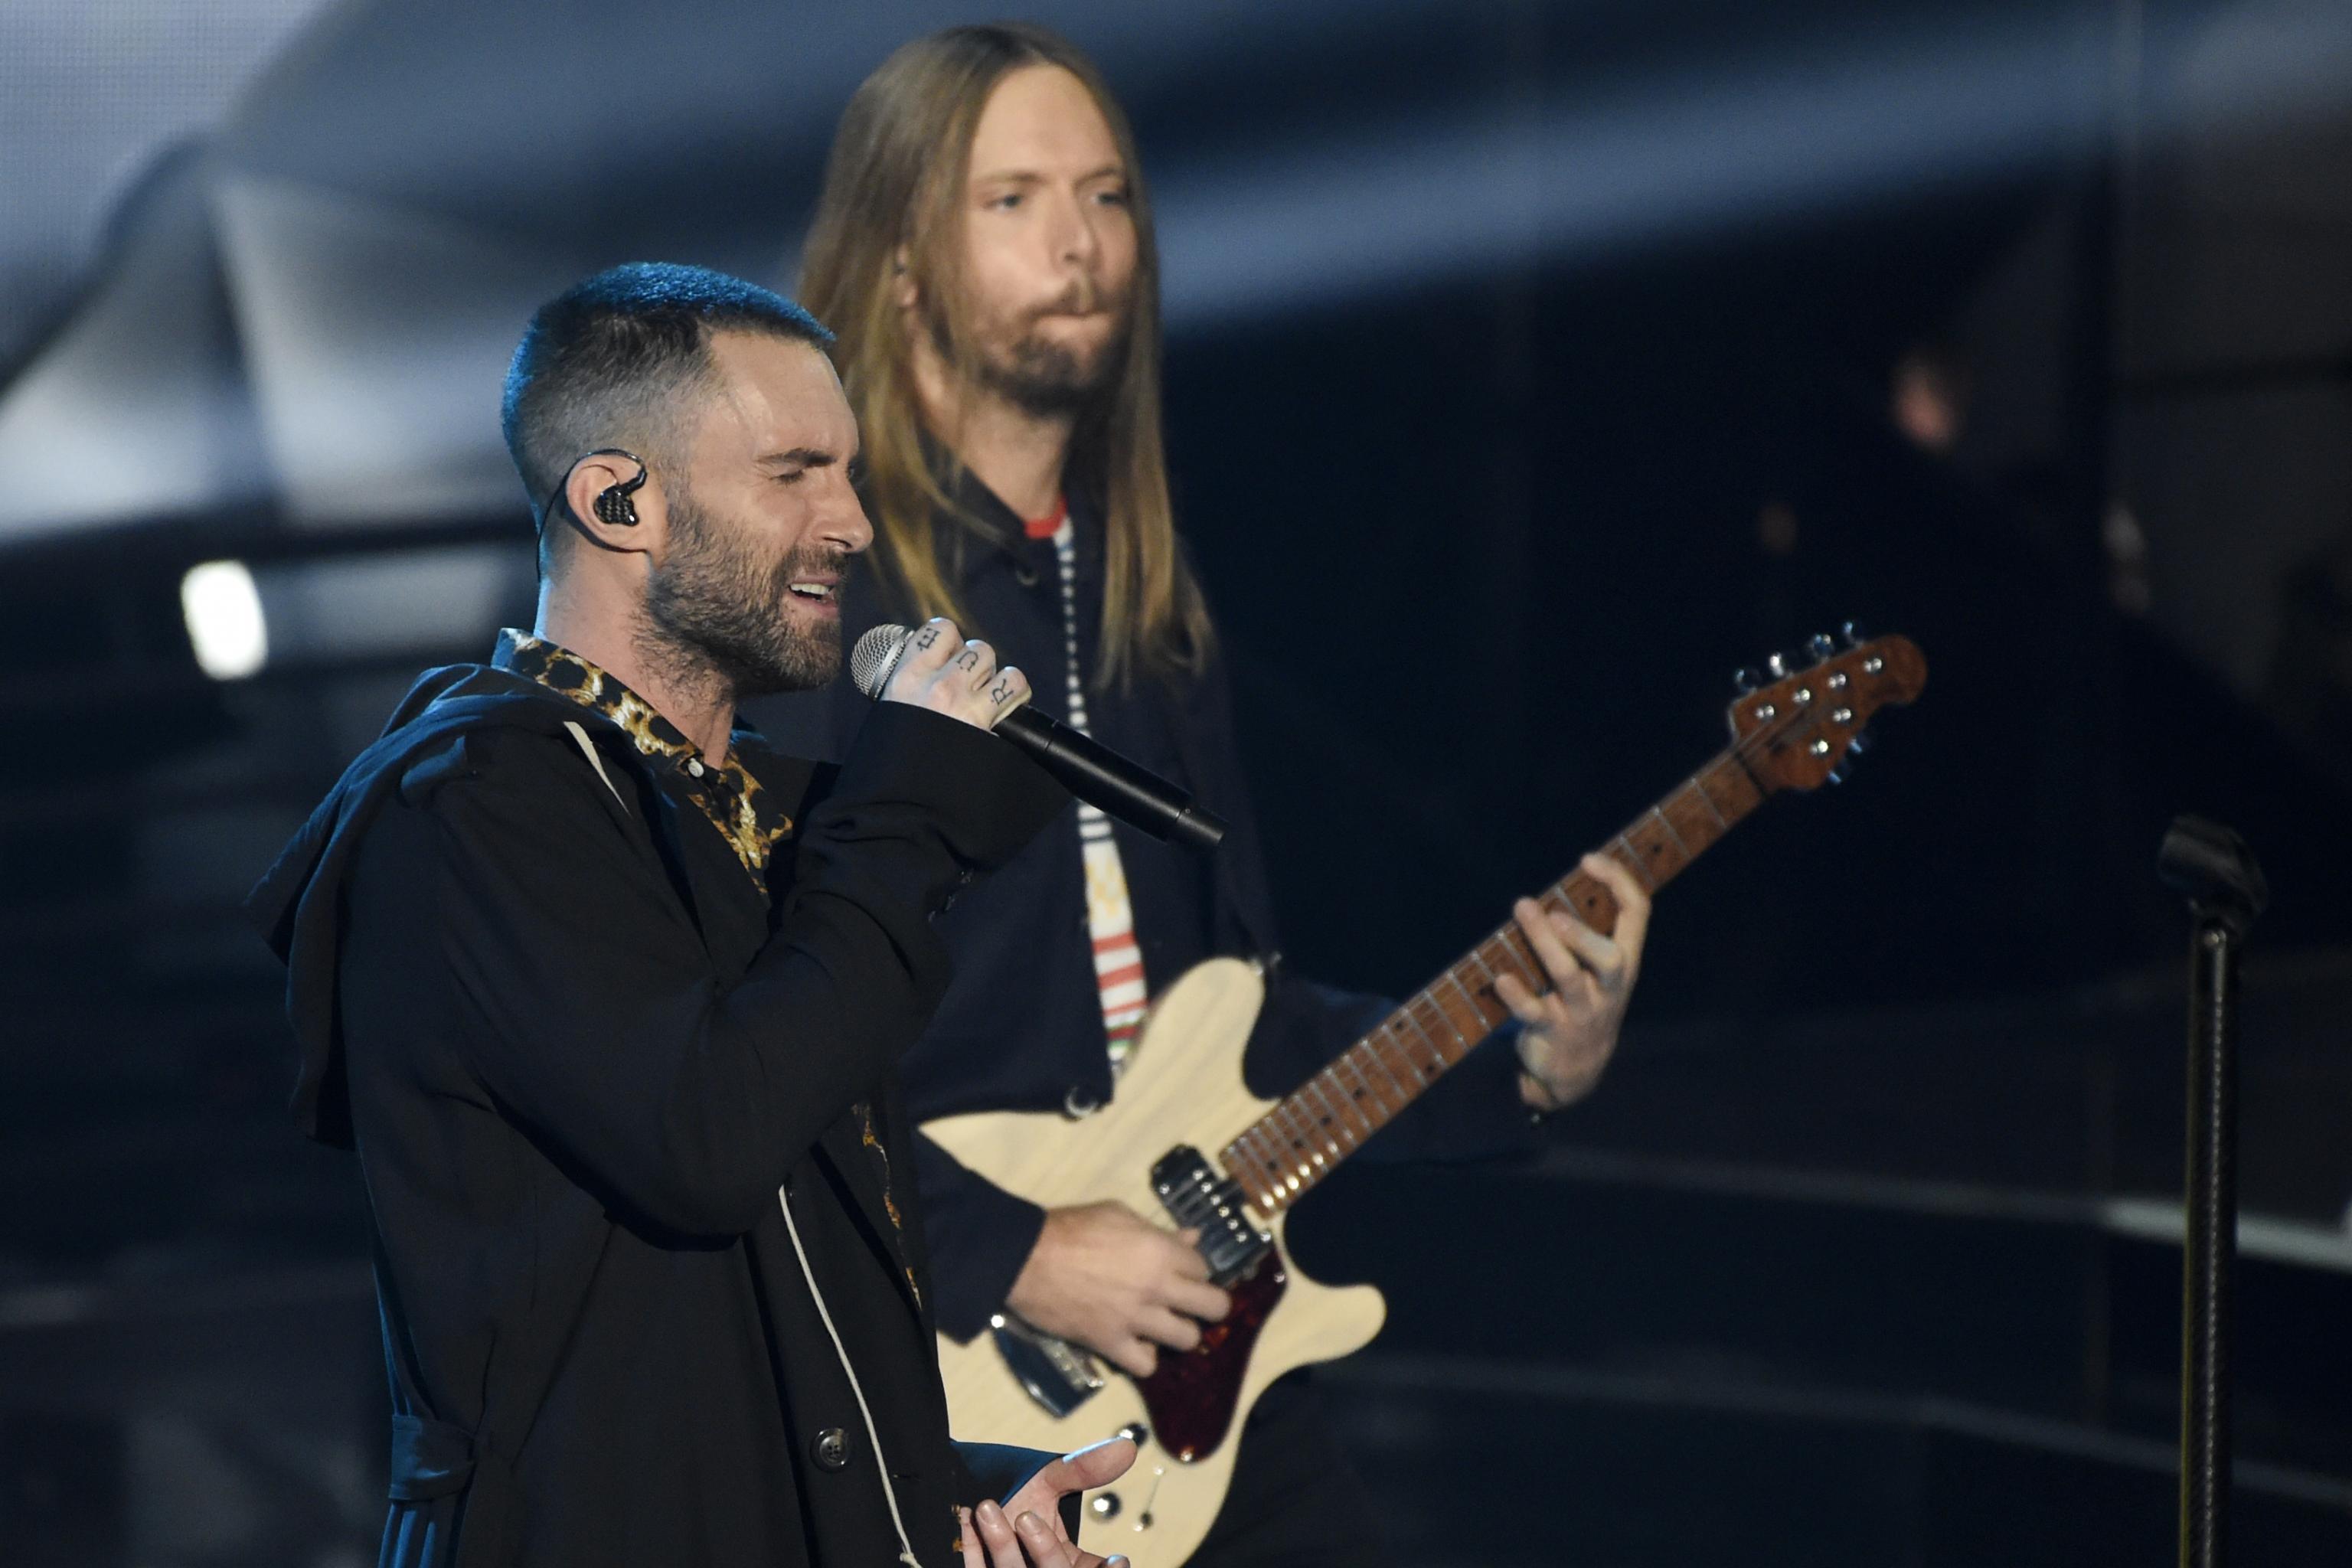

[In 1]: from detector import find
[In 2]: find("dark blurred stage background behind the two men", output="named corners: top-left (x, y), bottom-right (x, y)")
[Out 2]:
top-left (0, 0), bottom-right (2352, 1568)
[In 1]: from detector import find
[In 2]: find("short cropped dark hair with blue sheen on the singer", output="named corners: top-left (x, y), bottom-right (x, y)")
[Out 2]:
top-left (498, 261), bottom-right (832, 524)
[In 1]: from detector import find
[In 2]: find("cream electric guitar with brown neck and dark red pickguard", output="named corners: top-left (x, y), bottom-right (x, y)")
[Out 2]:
top-left (924, 626), bottom-right (1926, 1568)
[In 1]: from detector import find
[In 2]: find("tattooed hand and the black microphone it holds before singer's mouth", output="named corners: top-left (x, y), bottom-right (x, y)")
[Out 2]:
top-left (849, 621), bottom-right (1226, 851)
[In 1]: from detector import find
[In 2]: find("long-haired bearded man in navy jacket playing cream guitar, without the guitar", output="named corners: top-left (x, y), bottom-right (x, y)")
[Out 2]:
top-left (753, 26), bottom-right (1648, 1568)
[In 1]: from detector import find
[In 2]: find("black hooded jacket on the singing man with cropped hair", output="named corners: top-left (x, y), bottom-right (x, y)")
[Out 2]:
top-left (254, 668), bottom-right (1066, 1568)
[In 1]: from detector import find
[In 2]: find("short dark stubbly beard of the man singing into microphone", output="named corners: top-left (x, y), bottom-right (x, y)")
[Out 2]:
top-left (638, 487), bottom-right (851, 703)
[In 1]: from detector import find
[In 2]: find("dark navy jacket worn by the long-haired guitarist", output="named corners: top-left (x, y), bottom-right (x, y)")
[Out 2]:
top-left (748, 479), bottom-right (1534, 1340)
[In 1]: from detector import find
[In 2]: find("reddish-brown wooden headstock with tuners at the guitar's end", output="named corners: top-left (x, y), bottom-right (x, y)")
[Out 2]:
top-left (1731, 623), bottom-right (1926, 795)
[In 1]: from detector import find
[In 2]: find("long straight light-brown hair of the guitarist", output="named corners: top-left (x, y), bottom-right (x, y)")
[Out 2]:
top-left (799, 24), bottom-right (1211, 689)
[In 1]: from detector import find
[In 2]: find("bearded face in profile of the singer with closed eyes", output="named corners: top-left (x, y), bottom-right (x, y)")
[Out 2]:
top-left (645, 332), bottom-right (873, 698)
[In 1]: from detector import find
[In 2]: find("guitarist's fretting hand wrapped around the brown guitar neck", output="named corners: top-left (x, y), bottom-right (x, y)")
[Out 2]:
top-left (1494, 856), bottom-right (1648, 1109)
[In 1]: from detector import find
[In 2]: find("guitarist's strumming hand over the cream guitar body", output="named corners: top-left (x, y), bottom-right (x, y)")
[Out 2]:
top-left (1004, 1204), bottom-right (1233, 1377)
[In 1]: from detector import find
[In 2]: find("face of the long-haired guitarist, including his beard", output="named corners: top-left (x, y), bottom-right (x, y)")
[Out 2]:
top-left (962, 66), bottom-right (1136, 413)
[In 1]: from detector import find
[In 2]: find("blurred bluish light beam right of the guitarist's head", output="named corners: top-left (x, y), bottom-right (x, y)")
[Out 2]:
top-left (1152, 0), bottom-right (2352, 332)
